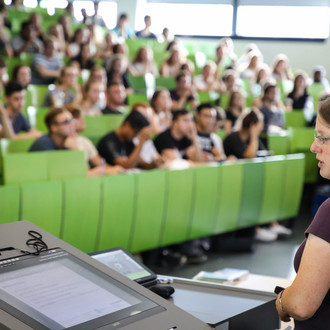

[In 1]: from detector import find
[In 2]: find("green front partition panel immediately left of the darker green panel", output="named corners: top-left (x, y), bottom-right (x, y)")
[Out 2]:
top-left (214, 162), bottom-right (243, 234)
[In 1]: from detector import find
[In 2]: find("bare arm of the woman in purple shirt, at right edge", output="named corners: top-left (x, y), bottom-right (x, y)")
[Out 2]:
top-left (276, 234), bottom-right (330, 321)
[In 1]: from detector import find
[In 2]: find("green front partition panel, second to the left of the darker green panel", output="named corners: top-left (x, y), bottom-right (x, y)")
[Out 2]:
top-left (188, 166), bottom-right (220, 239)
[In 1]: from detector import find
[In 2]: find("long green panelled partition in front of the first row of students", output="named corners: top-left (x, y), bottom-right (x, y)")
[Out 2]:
top-left (0, 151), bottom-right (305, 252)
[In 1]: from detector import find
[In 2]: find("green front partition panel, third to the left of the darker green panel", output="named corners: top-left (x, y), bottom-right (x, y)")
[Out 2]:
top-left (161, 169), bottom-right (195, 246)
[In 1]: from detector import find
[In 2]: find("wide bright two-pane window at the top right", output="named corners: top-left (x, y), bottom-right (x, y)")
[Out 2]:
top-left (145, 0), bottom-right (330, 39)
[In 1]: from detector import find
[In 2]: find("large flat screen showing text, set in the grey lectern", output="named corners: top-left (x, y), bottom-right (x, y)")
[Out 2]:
top-left (0, 248), bottom-right (164, 329)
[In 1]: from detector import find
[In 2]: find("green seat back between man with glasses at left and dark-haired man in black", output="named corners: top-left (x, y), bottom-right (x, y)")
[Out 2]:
top-left (81, 114), bottom-right (125, 145)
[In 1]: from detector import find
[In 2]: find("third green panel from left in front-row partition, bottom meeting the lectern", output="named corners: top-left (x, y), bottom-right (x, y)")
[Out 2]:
top-left (61, 177), bottom-right (101, 253)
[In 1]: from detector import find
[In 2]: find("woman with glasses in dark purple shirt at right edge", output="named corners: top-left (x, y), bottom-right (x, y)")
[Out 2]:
top-left (276, 97), bottom-right (330, 330)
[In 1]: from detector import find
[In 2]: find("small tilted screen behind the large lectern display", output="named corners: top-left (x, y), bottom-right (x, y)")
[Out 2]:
top-left (92, 248), bottom-right (157, 283)
